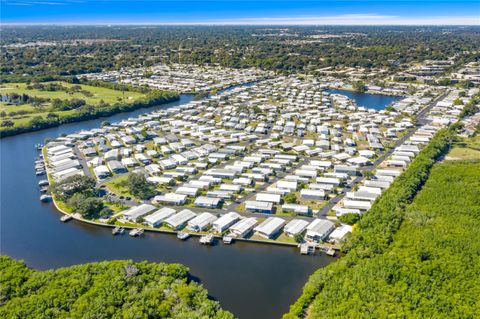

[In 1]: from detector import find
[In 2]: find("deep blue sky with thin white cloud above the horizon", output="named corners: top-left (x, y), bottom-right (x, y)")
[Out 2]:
top-left (0, 0), bottom-right (480, 25)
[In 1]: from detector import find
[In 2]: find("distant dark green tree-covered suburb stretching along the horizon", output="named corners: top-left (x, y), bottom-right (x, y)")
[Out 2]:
top-left (0, 26), bottom-right (480, 82)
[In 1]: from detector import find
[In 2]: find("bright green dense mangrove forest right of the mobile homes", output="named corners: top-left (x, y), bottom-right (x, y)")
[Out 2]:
top-left (284, 131), bottom-right (480, 318)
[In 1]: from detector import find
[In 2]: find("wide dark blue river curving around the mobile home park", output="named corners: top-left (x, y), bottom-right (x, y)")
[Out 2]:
top-left (0, 95), bottom-right (332, 319)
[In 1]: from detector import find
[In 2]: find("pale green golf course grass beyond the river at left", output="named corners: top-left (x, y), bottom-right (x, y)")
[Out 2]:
top-left (0, 82), bottom-right (145, 127)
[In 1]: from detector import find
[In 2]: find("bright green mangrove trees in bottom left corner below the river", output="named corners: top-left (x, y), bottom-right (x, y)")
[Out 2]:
top-left (0, 256), bottom-right (233, 319)
